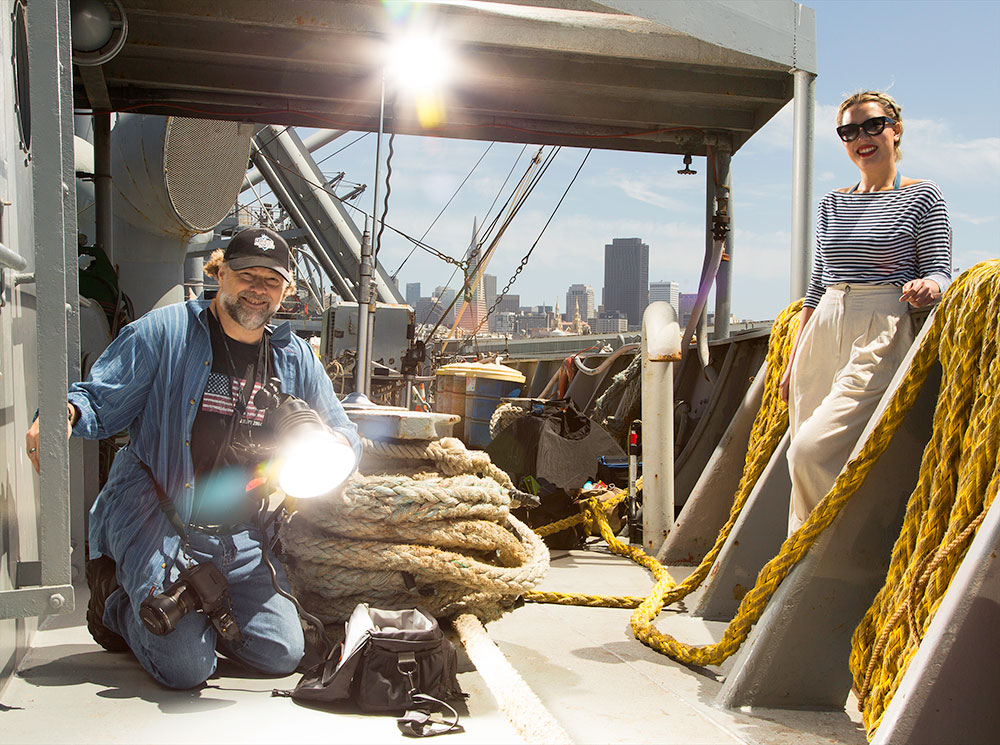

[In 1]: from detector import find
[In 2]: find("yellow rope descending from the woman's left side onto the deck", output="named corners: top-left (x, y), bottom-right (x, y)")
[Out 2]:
top-left (525, 300), bottom-right (802, 612)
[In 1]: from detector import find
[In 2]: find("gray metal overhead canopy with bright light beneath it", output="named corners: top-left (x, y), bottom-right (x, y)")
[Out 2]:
top-left (75, 0), bottom-right (816, 155)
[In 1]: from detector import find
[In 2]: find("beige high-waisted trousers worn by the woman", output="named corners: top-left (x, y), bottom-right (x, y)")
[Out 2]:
top-left (788, 284), bottom-right (914, 533)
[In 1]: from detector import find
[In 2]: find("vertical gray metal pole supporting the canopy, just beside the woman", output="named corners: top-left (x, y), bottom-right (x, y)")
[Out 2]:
top-left (789, 70), bottom-right (816, 300)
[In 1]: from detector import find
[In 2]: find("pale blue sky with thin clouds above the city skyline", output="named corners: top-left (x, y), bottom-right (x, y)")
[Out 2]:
top-left (246, 0), bottom-right (1000, 320)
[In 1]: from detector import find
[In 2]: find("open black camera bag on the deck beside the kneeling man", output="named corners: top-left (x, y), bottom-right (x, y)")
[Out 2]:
top-left (291, 604), bottom-right (464, 737)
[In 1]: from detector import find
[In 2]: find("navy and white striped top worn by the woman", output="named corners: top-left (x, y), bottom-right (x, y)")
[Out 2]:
top-left (805, 181), bottom-right (951, 308)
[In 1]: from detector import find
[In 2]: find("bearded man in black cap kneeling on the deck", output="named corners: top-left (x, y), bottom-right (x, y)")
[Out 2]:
top-left (26, 228), bottom-right (361, 688)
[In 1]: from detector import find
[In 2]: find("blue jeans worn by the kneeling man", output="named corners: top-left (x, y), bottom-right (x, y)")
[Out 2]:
top-left (104, 527), bottom-right (305, 689)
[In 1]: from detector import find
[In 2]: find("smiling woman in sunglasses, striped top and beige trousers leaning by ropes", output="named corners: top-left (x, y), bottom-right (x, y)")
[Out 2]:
top-left (781, 91), bottom-right (951, 532)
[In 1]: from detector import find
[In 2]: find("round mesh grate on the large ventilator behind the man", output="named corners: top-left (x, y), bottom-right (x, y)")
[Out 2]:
top-left (163, 116), bottom-right (253, 232)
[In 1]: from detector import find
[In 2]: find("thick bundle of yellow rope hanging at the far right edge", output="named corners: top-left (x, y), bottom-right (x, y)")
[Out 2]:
top-left (850, 261), bottom-right (1000, 739)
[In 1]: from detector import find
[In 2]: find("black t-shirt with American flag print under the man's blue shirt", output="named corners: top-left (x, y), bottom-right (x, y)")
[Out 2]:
top-left (191, 310), bottom-right (268, 522)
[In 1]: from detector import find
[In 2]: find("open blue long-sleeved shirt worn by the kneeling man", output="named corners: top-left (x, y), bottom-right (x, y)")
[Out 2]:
top-left (69, 300), bottom-right (361, 591)
